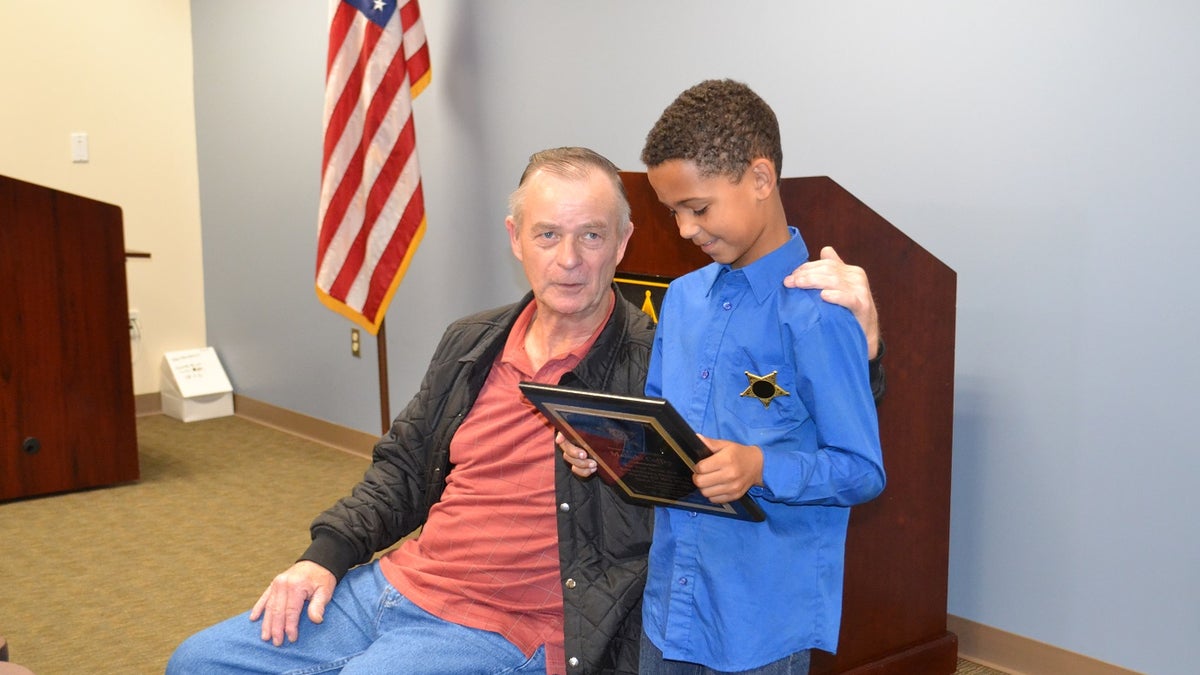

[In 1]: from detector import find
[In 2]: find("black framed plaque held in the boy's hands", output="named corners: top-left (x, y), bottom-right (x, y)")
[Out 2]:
top-left (521, 382), bottom-right (766, 521)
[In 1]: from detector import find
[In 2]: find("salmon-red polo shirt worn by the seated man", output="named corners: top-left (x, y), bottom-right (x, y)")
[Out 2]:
top-left (379, 296), bottom-right (611, 675)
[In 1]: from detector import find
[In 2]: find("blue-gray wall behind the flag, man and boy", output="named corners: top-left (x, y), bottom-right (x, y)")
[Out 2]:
top-left (193, 0), bottom-right (1200, 674)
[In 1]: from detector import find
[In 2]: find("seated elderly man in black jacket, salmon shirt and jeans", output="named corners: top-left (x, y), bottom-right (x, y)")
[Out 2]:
top-left (167, 148), bottom-right (875, 675)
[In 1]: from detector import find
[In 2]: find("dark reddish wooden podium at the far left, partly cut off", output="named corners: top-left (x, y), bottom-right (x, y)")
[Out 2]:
top-left (0, 177), bottom-right (138, 501)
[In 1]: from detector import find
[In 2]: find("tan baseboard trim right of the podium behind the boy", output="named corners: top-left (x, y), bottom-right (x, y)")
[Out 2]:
top-left (946, 614), bottom-right (1141, 675)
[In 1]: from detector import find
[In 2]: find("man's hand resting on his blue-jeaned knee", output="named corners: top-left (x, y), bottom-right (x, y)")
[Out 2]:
top-left (250, 560), bottom-right (337, 646)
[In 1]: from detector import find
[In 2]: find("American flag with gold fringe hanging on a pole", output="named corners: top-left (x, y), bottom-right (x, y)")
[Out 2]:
top-left (317, 0), bottom-right (430, 335)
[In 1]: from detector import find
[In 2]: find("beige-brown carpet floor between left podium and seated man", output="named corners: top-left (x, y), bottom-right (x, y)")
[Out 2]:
top-left (0, 416), bottom-right (997, 675)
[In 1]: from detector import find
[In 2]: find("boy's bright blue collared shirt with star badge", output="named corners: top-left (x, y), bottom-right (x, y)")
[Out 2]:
top-left (643, 228), bottom-right (884, 670)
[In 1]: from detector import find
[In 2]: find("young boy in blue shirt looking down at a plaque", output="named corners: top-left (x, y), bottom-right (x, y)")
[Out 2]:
top-left (564, 80), bottom-right (884, 675)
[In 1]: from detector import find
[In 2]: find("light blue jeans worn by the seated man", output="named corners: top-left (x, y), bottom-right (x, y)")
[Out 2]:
top-left (167, 563), bottom-right (546, 675)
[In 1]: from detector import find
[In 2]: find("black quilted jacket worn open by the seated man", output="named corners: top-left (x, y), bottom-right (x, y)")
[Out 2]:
top-left (301, 288), bottom-right (654, 674)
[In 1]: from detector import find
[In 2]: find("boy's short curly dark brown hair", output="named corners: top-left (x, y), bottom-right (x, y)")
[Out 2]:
top-left (642, 79), bottom-right (784, 180)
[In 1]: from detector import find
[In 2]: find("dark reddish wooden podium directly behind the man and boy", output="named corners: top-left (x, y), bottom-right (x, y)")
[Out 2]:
top-left (617, 172), bottom-right (958, 675)
